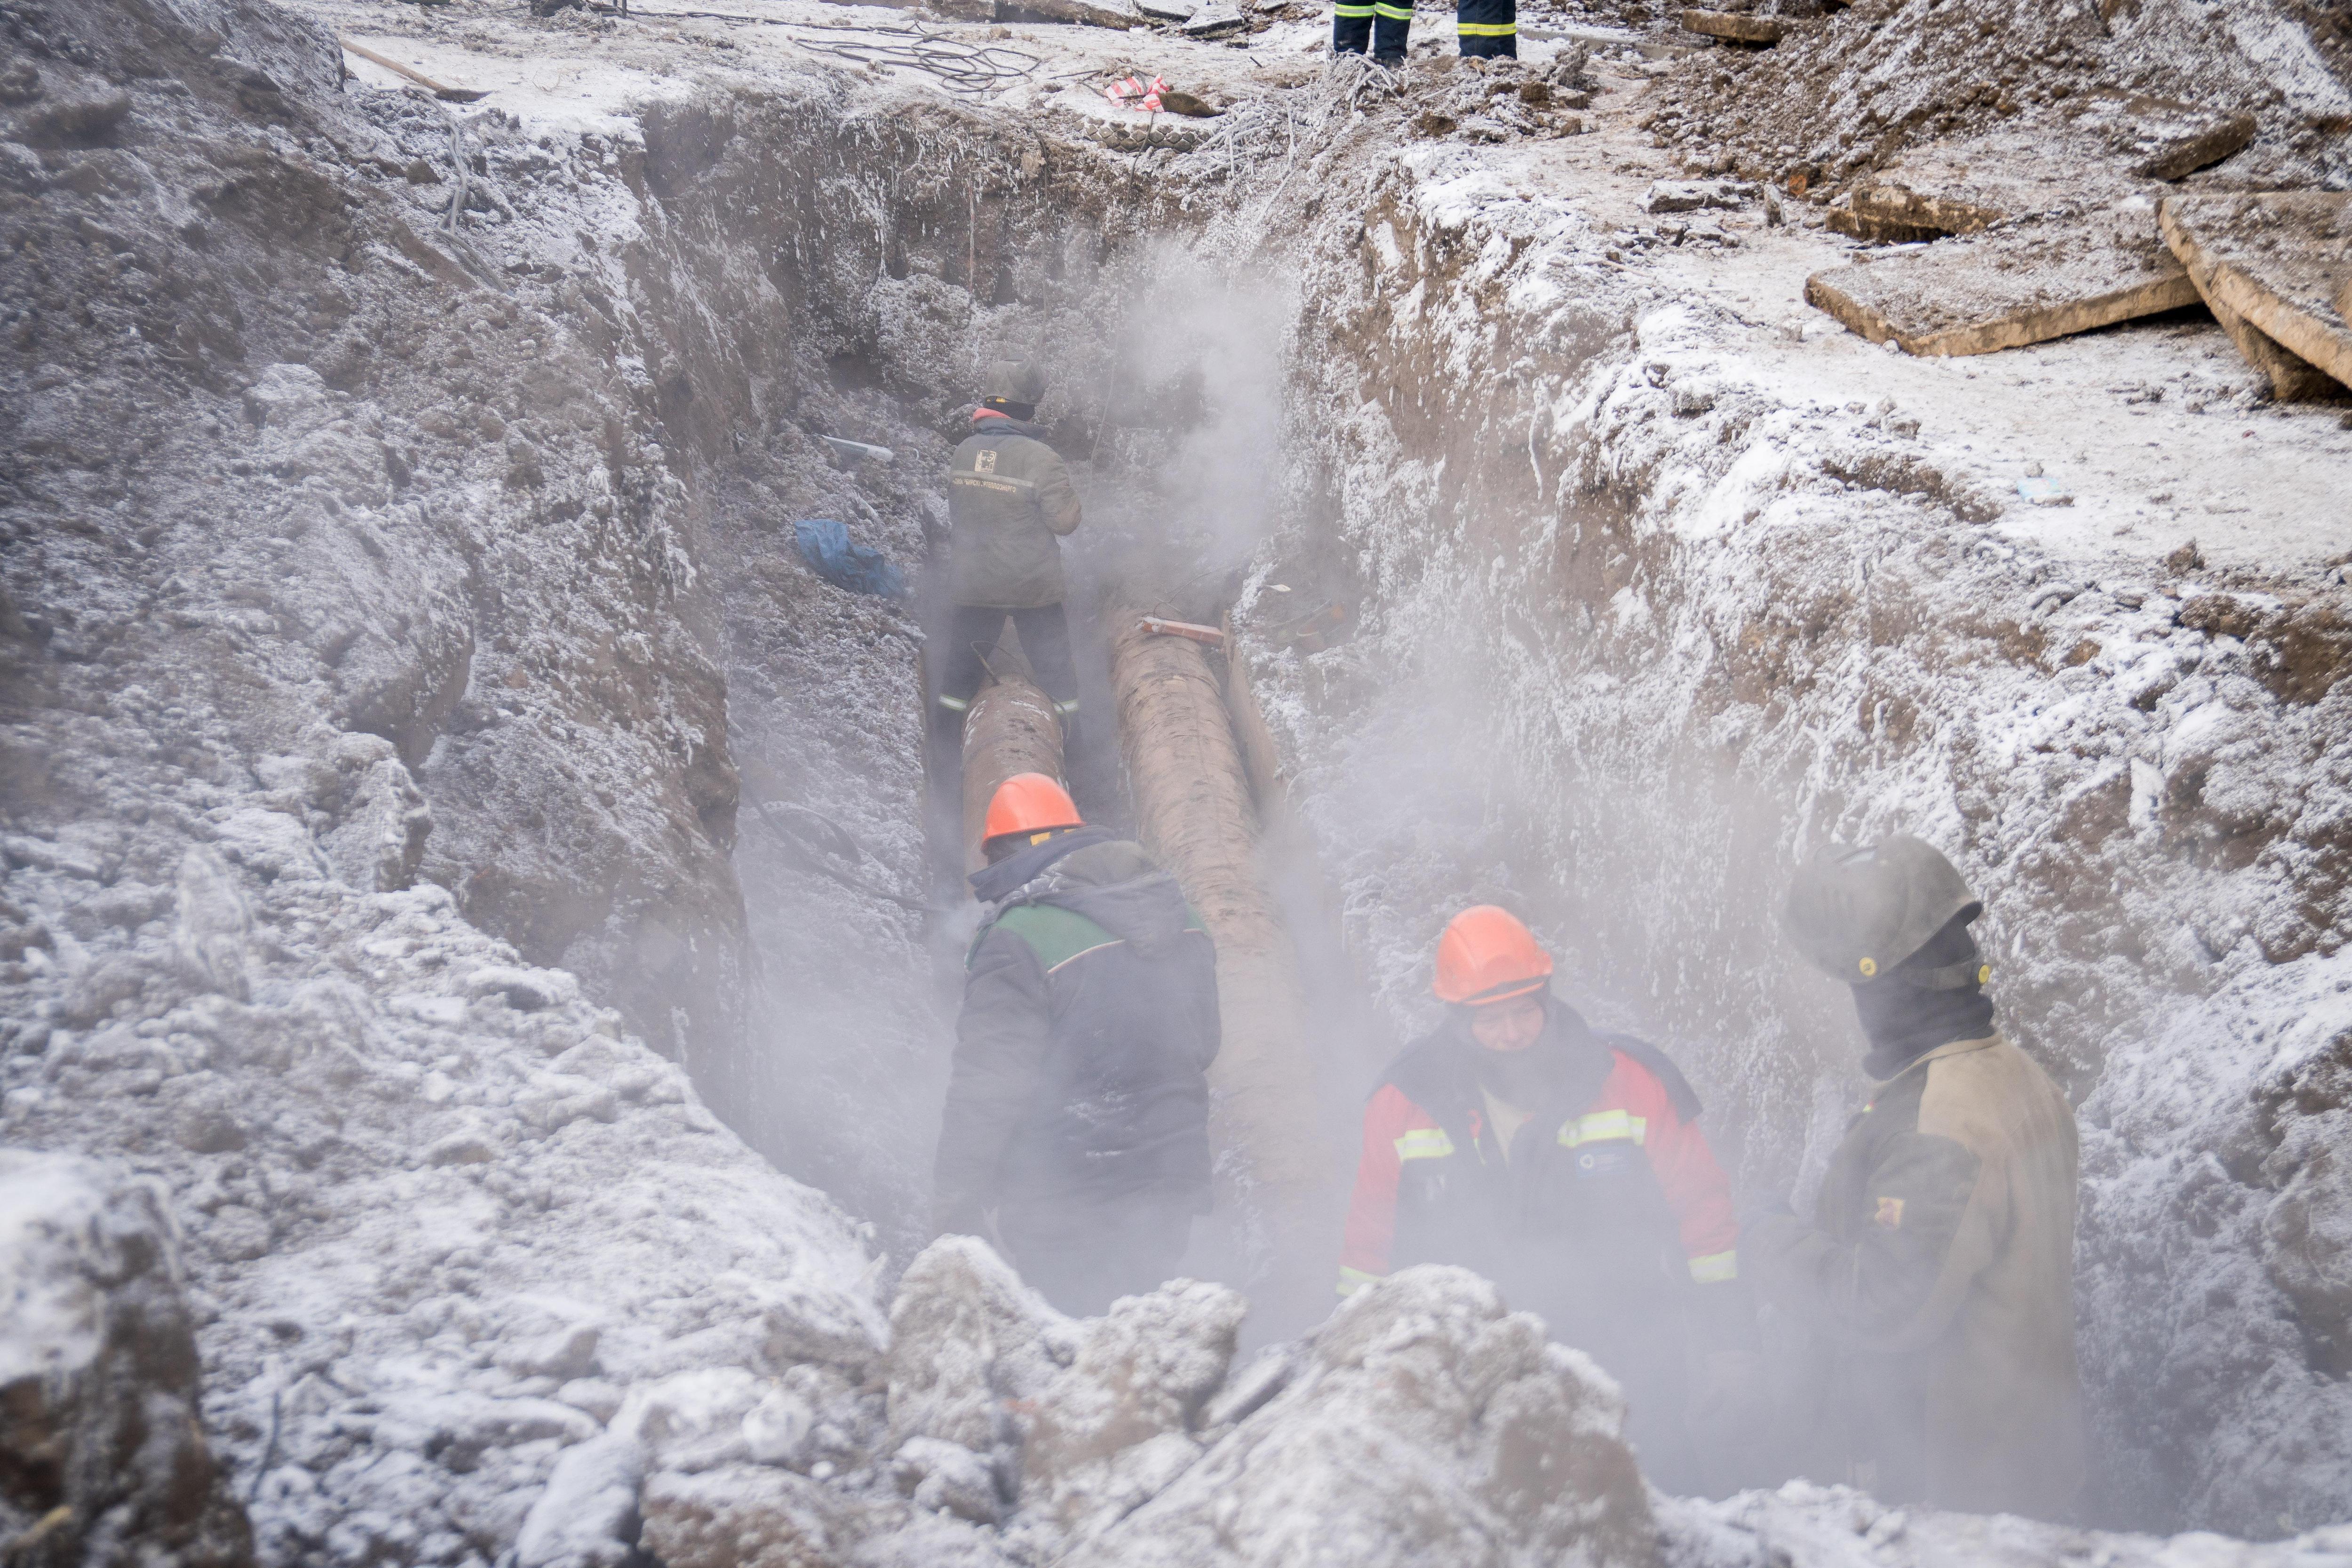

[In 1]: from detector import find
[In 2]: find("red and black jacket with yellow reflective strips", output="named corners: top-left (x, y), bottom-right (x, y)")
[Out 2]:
top-left (1338, 999), bottom-right (1745, 1375)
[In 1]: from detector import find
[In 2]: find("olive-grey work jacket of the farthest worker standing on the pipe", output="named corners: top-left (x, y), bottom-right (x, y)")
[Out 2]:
top-left (948, 411), bottom-right (1077, 609)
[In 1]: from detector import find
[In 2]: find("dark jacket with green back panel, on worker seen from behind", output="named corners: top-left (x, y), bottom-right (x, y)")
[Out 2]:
top-left (934, 828), bottom-right (1218, 1210)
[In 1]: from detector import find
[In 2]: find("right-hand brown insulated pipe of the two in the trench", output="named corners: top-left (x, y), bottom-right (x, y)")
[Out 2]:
top-left (1110, 609), bottom-right (1341, 1326)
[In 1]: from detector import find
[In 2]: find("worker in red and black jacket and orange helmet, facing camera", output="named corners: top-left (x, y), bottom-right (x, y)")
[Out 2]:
top-left (1338, 905), bottom-right (1764, 1490)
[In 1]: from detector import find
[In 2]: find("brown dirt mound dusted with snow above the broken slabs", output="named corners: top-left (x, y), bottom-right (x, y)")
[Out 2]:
top-left (1651, 0), bottom-right (2352, 199)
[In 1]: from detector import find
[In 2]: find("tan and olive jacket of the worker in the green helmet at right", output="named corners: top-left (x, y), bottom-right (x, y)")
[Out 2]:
top-left (1745, 1035), bottom-right (2084, 1519)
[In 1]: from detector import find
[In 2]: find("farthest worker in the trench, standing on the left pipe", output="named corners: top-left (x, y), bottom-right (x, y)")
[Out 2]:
top-left (936, 360), bottom-right (1080, 733)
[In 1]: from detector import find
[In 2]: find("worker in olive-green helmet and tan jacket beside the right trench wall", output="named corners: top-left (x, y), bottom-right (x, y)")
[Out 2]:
top-left (1745, 835), bottom-right (2084, 1519)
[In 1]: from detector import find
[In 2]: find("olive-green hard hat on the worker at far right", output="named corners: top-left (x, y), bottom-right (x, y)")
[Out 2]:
top-left (1780, 832), bottom-right (1985, 990)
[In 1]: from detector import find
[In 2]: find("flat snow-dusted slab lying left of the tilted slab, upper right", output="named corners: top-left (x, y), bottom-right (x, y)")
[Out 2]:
top-left (1804, 202), bottom-right (2197, 355)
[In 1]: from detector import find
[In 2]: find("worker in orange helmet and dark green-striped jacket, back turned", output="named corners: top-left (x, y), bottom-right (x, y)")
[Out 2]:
top-left (934, 773), bottom-right (1218, 1316)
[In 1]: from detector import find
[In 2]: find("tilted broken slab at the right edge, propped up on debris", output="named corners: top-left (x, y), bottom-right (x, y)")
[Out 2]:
top-left (2159, 191), bottom-right (2352, 402)
